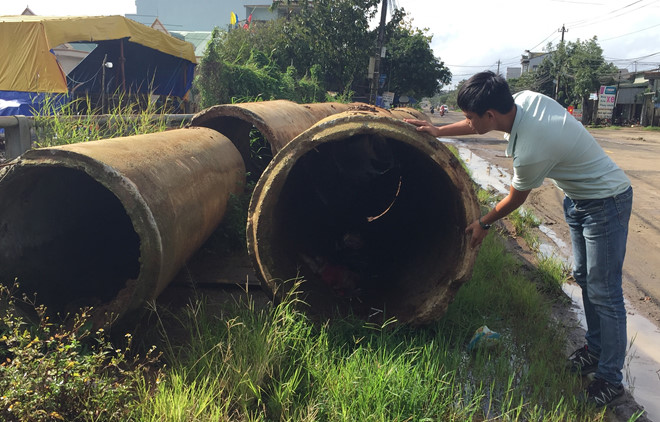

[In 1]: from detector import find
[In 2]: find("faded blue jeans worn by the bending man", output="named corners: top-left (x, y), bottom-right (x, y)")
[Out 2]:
top-left (564, 187), bottom-right (633, 385)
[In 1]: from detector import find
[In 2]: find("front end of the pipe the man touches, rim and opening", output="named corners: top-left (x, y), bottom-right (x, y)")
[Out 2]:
top-left (247, 112), bottom-right (479, 324)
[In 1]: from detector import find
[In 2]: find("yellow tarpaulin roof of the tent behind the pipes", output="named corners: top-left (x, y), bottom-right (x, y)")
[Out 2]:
top-left (0, 16), bottom-right (197, 93)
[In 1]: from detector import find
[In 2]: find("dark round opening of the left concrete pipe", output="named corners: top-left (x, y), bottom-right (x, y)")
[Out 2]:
top-left (0, 166), bottom-right (140, 312)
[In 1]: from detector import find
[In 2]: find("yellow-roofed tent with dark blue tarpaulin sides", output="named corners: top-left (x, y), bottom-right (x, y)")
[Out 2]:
top-left (0, 16), bottom-right (196, 115)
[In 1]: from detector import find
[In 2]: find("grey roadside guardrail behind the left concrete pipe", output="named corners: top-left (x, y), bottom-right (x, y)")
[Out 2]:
top-left (0, 114), bottom-right (193, 160)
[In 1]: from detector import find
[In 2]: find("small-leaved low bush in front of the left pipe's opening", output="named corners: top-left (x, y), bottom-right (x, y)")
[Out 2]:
top-left (0, 285), bottom-right (160, 422)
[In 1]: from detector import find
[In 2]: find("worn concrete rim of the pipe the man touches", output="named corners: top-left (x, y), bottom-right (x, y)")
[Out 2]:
top-left (247, 111), bottom-right (479, 324)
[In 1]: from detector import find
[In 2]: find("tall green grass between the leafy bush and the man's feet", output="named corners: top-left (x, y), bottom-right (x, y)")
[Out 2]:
top-left (121, 229), bottom-right (632, 421)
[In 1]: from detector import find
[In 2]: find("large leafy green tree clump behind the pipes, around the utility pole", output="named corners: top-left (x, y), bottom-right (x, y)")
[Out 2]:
top-left (195, 0), bottom-right (451, 106)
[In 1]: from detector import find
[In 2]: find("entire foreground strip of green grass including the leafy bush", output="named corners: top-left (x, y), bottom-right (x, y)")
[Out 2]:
top-left (0, 232), bottom-right (628, 421)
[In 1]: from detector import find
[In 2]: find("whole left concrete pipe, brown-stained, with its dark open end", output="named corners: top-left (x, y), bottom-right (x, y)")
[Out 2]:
top-left (0, 127), bottom-right (245, 317)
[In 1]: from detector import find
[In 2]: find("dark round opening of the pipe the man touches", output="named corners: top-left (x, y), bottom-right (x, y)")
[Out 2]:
top-left (260, 133), bottom-right (467, 320)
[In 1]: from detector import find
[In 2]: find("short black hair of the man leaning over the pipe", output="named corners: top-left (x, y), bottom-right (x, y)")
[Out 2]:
top-left (456, 71), bottom-right (513, 116)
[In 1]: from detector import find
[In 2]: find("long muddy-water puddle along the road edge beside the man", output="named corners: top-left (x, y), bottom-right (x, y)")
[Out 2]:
top-left (440, 138), bottom-right (660, 421)
